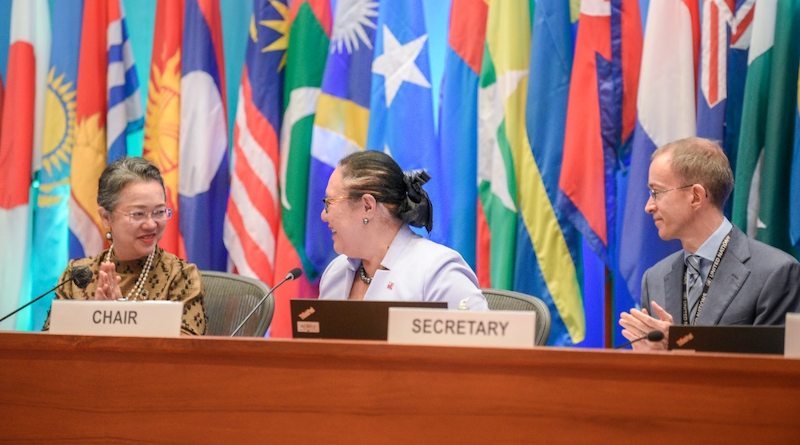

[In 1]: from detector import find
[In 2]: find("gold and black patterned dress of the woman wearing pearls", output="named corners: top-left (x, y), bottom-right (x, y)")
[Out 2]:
top-left (42, 247), bottom-right (207, 335)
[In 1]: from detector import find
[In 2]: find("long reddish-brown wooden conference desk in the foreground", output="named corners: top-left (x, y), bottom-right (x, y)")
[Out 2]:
top-left (0, 332), bottom-right (800, 445)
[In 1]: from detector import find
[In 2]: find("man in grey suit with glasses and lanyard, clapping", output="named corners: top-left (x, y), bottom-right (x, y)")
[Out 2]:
top-left (619, 138), bottom-right (800, 350)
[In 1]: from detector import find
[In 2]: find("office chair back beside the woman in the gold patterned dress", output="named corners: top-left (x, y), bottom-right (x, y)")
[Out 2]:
top-left (200, 270), bottom-right (275, 337)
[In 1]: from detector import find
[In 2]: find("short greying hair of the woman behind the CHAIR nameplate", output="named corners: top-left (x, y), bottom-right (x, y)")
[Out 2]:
top-left (97, 157), bottom-right (167, 212)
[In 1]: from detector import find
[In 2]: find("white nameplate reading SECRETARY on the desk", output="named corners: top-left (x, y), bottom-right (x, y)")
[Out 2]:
top-left (387, 307), bottom-right (536, 348)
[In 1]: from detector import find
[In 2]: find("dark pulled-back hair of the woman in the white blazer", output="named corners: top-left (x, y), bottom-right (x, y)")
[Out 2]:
top-left (339, 150), bottom-right (433, 232)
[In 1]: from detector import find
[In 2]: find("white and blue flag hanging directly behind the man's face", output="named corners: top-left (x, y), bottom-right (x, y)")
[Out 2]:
top-left (619, 0), bottom-right (700, 302)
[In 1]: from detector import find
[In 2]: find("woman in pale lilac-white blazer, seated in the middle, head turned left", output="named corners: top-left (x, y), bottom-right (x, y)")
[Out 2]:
top-left (320, 150), bottom-right (488, 310)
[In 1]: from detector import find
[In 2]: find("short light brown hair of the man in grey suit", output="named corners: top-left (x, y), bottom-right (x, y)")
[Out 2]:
top-left (650, 137), bottom-right (733, 210)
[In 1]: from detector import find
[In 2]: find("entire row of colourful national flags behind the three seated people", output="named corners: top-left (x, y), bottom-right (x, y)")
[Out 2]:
top-left (0, 0), bottom-right (800, 345)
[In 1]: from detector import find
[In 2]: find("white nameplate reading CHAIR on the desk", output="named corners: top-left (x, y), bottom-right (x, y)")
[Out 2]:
top-left (50, 300), bottom-right (183, 337)
